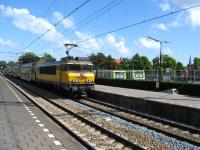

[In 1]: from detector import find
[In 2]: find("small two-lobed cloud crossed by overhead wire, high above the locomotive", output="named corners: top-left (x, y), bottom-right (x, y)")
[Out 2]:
top-left (53, 11), bottom-right (74, 29)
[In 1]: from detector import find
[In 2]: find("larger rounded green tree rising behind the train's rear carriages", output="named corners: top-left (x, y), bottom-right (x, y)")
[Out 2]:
top-left (18, 52), bottom-right (40, 64)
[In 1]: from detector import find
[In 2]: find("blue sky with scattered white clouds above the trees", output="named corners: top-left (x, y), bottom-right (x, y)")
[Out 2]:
top-left (0, 0), bottom-right (200, 65)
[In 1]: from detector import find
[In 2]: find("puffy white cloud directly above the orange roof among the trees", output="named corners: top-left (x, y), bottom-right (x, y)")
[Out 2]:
top-left (105, 34), bottom-right (130, 54)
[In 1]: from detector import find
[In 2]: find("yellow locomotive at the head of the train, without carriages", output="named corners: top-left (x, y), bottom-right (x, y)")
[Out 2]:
top-left (35, 58), bottom-right (94, 97)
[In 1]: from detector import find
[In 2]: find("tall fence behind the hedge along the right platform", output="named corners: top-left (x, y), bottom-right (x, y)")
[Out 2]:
top-left (95, 70), bottom-right (200, 84)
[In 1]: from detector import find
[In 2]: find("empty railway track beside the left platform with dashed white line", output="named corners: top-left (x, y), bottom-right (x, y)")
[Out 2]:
top-left (5, 77), bottom-right (146, 150)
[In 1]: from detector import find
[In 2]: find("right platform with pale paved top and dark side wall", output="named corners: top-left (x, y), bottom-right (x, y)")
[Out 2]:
top-left (91, 85), bottom-right (200, 127)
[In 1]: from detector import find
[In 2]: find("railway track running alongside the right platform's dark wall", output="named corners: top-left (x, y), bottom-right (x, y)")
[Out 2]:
top-left (79, 98), bottom-right (200, 146)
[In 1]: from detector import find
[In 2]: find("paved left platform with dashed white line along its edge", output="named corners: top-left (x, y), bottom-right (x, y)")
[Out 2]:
top-left (0, 76), bottom-right (86, 150)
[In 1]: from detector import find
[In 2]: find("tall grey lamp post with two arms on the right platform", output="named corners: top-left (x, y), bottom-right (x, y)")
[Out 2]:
top-left (148, 37), bottom-right (170, 89)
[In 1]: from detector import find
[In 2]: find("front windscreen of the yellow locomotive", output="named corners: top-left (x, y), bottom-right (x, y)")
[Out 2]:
top-left (63, 64), bottom-right (92, 72)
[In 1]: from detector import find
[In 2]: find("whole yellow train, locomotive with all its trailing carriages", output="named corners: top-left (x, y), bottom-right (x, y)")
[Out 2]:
top-left (6, 57), bottom-right (95, 97)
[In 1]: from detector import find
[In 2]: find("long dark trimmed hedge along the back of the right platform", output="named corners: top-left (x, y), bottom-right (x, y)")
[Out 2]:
top-left (95, 78), bottom-right (200, 96)
